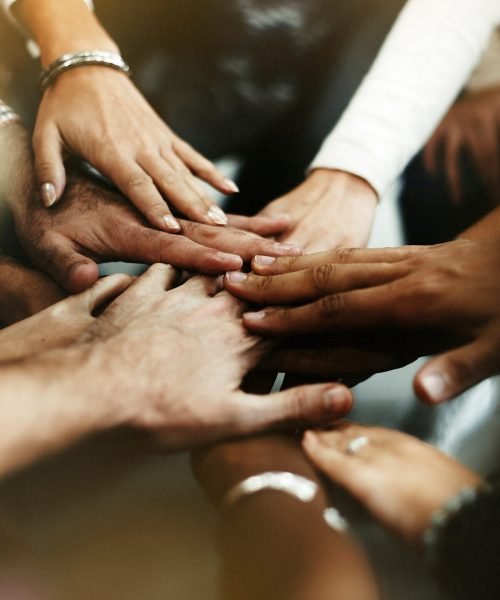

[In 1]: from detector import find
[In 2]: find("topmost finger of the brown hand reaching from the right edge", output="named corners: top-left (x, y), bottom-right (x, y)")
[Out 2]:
top-left (252, 246), bottom-right (429, 275)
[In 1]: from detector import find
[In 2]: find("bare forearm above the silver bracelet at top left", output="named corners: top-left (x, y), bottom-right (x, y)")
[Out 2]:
top-left (13, 0), bottom-right (118, 66)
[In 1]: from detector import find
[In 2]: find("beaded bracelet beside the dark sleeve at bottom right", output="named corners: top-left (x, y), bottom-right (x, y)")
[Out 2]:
top-left (422, 484), bottom-right (491, 566)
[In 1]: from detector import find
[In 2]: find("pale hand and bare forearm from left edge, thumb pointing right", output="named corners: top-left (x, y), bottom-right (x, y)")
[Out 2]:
top-left (0, 265), bottom-right (351, 474)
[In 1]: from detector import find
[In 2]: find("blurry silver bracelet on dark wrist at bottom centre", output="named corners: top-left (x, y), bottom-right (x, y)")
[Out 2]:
top-left (222, 471), bottom-right (349, 533)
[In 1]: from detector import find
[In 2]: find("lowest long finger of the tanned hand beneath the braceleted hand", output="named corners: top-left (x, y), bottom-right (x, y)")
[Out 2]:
top-left (122, 227), bottom-right (243, 275)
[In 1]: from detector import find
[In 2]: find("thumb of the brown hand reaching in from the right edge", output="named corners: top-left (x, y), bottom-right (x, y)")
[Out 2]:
top-left (414, 338), bottom-right (500, 404)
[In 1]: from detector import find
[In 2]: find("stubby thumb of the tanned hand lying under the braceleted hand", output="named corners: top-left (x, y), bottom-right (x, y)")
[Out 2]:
top-left (33, 235), bottom-right (99, 294)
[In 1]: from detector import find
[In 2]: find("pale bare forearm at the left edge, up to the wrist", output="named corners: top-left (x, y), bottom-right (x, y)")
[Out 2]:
top-left (0, 349), bottom-right (120, 476)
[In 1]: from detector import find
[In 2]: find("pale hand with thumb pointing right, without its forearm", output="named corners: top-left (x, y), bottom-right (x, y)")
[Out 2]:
top-left (75, 265), bottom-right (351, 448)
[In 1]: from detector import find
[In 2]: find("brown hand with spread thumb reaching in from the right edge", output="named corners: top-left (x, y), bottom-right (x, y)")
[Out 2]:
top-left (225, 239), bottom-right (500, 403)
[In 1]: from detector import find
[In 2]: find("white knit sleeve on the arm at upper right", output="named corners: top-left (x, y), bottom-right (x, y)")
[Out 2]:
top-left (311, 0), bottom-right (500, 195)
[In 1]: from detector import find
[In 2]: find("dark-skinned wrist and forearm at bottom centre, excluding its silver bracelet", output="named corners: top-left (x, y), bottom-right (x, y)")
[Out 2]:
top-left (193, 436), bottom-right (379, 600)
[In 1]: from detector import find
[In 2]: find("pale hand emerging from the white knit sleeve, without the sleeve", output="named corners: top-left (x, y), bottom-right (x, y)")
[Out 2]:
top-left (260, 169), bottom-right (377, 252)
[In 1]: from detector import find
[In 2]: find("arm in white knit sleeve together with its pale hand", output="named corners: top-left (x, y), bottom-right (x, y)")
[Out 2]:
top-left (263, 0), bottom-right (500, 252)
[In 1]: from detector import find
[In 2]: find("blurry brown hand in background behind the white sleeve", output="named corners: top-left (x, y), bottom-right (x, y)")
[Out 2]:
top-left (424, 87), bottom-right (500, 203)
